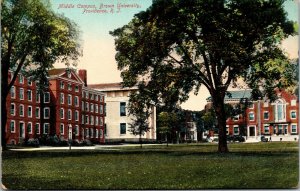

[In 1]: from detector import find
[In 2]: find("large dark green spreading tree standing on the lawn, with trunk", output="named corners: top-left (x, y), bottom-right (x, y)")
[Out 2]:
top-left (111, 0), bottom-right (294, 152)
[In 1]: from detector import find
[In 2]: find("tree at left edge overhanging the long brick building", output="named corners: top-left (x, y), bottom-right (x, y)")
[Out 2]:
top-left (1, 0), bottom-right (81, 149)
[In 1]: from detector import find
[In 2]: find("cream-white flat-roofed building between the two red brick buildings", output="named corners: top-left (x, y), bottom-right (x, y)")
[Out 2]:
top-left (88, 83), bottom-right (156, 142)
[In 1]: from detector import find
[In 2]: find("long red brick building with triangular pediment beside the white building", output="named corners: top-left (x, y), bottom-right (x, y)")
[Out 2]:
top-left (6, 68), bottom-right (105, 144)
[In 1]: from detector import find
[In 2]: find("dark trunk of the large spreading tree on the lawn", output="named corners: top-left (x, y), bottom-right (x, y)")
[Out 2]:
top-left (213, 92), bottom-right (229, 153)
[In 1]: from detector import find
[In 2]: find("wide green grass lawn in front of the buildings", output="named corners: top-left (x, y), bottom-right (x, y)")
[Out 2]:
top-left (2, 142), bottom-right (299, 190)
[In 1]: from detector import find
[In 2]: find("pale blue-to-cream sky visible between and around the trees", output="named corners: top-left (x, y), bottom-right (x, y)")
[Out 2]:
top-left (50, 0), bottom-right (298, 110)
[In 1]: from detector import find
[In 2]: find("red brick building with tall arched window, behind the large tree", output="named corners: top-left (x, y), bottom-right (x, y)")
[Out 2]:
top-left (206, 89), bottom-right (299, 141)
